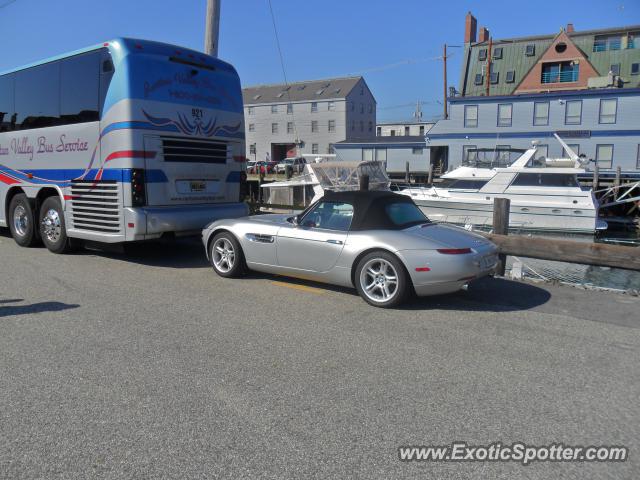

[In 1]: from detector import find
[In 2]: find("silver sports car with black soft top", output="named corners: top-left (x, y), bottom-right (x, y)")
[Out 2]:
top-left (202, 191), bottom-right (498, 307)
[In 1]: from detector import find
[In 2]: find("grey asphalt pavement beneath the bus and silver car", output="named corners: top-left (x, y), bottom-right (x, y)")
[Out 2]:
top-left (0, 230), bottom-right (640, 480)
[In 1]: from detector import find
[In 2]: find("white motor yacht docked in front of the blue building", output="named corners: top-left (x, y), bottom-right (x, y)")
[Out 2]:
top-left (399, 135), bottom-right (607, 234)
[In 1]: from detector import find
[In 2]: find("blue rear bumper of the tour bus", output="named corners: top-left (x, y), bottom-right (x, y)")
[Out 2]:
top-left (124, 202), bottom-right (249, 241)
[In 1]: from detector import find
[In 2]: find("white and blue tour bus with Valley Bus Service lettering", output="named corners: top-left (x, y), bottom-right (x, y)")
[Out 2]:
top-left (0, 38), bottom-right (248, 253)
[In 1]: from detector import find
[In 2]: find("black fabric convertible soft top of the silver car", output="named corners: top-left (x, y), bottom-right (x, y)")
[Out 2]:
top-left (321, 190), bottom-right (420, 231)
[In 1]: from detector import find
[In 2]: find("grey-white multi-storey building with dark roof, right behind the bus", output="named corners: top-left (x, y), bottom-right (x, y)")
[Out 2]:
top-left (242, 77), bottom-right (376, 160)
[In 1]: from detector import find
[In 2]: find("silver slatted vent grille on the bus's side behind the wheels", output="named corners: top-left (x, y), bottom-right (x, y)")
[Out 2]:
top-left (69, 180), bottom-right (122, 234)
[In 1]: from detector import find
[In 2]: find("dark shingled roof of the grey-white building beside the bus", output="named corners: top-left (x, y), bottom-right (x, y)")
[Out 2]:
top-left (242, 76), bottom-right (364, 105)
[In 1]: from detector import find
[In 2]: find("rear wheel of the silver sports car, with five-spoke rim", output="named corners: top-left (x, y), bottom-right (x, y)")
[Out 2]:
top-left (355, 251), bottom-right (410, 308)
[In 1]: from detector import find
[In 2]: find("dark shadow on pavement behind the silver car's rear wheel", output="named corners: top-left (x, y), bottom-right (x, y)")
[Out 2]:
top-left (408, 277), bottom-right (551, 312)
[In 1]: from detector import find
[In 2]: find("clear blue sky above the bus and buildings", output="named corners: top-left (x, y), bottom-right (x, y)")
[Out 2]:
top-left (0, 0), bottom-right (640, 120)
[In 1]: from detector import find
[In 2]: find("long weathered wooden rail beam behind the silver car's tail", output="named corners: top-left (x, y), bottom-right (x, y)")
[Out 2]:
top-left (478, 232), bottom-right (640, 271)
